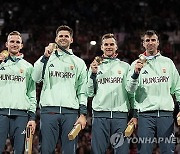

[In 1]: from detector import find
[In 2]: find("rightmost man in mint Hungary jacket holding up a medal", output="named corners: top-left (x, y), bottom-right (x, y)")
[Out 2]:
top-left (126, 30), bottom-right (180, 154)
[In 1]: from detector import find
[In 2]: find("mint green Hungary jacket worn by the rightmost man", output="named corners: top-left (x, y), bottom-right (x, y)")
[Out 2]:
top-left (126, 53), bottom-right (180, 112)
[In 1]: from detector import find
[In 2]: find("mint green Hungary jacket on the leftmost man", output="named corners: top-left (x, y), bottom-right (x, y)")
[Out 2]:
top-left (0, 54), bottom-right (37, 120)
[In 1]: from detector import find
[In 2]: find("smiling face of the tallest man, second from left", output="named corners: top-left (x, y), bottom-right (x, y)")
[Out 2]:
top-left (55, 30), bottom-right (73, 49)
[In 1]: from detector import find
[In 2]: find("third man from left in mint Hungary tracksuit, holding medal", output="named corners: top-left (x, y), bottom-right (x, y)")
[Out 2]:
top-left (87, 34), bottom-right (137, 154)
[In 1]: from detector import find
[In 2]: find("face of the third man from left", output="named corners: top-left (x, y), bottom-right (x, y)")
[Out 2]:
top-left (101, 38), bottom-right (118, 57)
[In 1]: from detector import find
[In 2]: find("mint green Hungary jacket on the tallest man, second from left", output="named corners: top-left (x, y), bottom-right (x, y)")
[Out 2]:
top-left (32, 49), bottom-right (87, 114)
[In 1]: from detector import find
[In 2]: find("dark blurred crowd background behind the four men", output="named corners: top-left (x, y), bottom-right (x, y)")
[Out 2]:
top-left (0, 0), bottom-right (180, 154)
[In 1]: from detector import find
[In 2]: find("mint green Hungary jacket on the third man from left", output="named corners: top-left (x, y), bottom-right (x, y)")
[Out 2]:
top-left (87, 58), bottom-right (134, 118)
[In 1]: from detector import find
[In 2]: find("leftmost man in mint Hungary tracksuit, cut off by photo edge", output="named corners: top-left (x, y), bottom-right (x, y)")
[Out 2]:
top-left (0, 31), bottom-right (36, 154)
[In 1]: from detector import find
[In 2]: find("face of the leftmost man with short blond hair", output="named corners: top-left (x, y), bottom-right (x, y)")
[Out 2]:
top-left (5, 34), bottom-right (23, 55)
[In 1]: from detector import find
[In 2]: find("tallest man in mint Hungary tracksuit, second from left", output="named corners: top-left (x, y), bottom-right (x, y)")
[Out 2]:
top-left (33, 25), bottom-right (87, 154)
